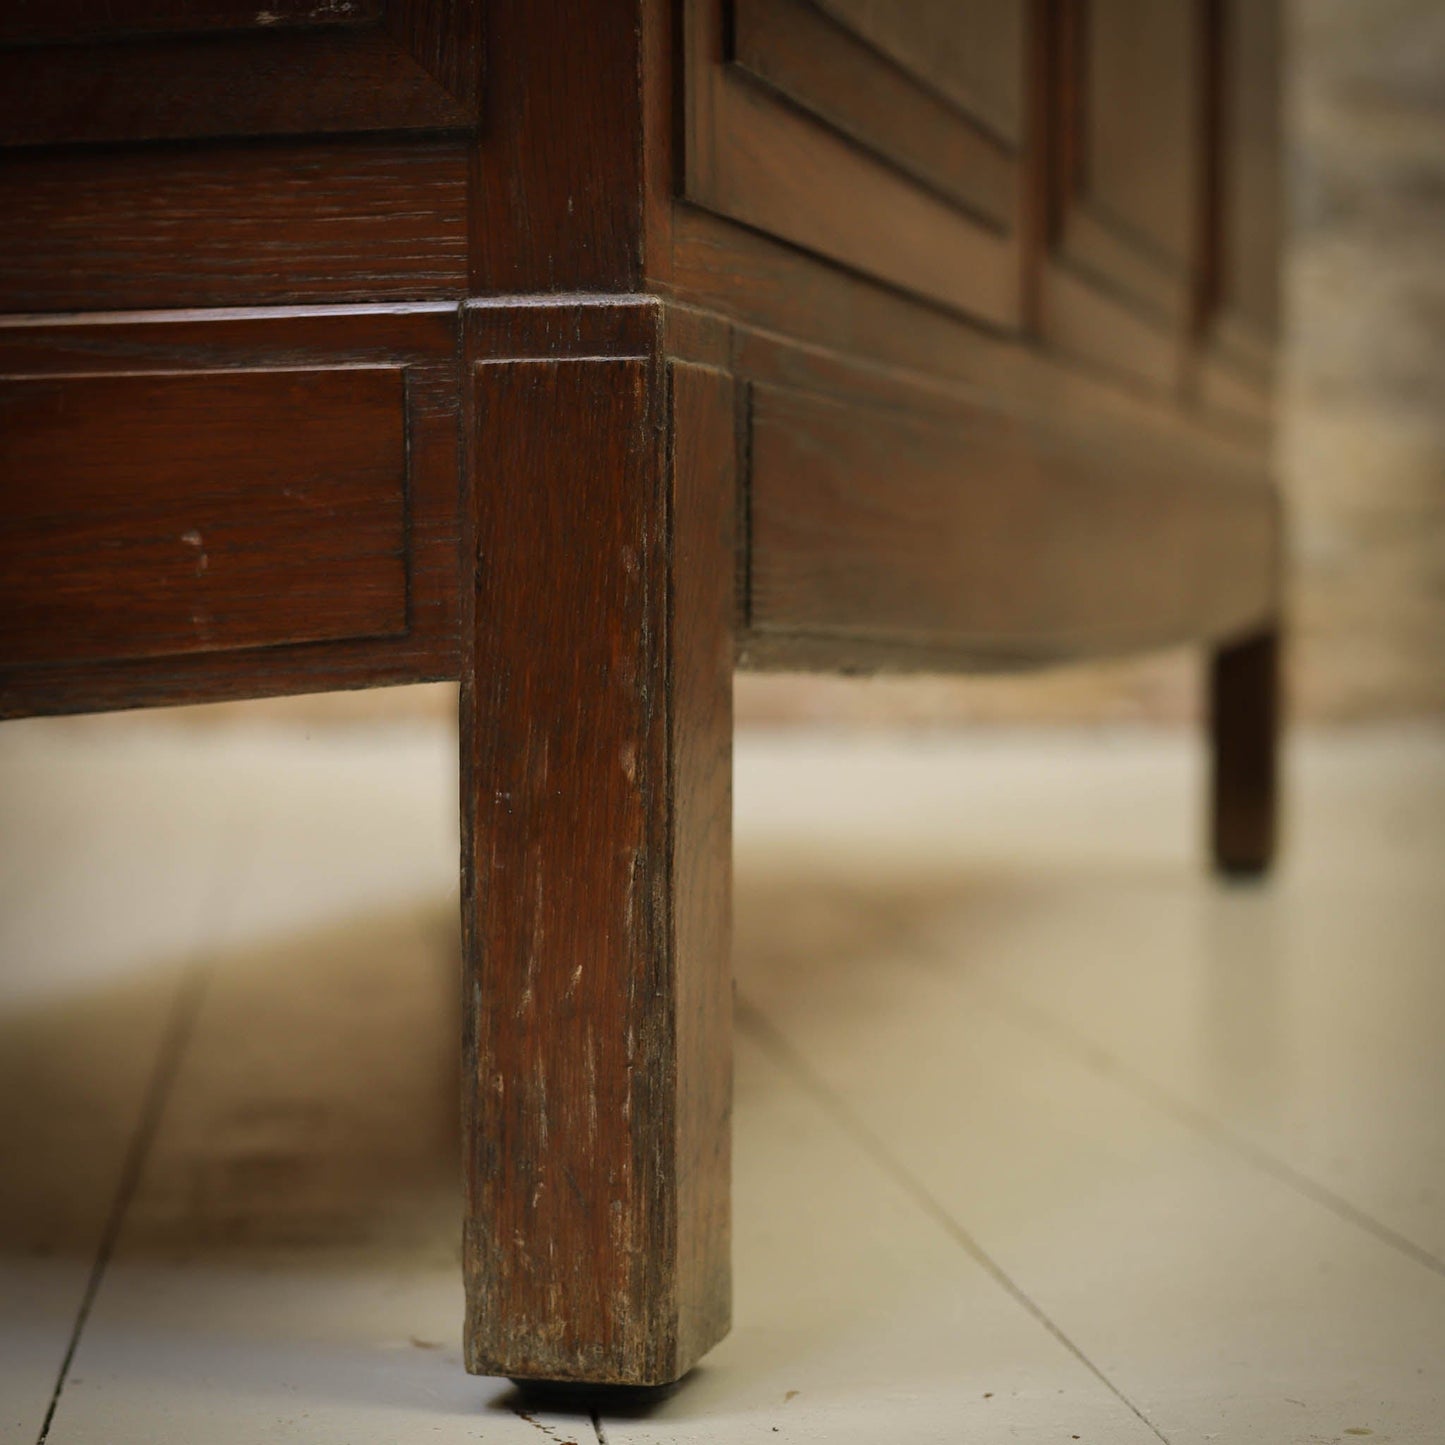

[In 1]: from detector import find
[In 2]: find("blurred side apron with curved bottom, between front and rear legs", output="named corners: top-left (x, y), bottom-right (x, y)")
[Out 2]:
top-left (743, 386), bottom-right (1277, 668)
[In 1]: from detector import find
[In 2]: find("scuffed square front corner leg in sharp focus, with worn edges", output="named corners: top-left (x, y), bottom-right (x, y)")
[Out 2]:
top-left (461, 319), bottom-right (734, 1384)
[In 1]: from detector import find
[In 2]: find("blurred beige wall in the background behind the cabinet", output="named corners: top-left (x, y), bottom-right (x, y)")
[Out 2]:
top-left (137, 0), bottom-right (1445, 725)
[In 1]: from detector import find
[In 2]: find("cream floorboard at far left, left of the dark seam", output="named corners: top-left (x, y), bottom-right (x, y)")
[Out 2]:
top-left (0, 723), bottom-right (257, 1445)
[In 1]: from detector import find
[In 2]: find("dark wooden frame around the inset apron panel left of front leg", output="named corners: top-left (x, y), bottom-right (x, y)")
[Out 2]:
top-left (0, 305), bottom-right (461, 718)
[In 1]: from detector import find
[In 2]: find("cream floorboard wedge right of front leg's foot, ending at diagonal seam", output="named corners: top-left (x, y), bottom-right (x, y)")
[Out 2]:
top-left (589, 1026), bottom-right (1156, 1445)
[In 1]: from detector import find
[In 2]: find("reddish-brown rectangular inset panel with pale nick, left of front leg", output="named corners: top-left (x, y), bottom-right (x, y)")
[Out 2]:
top-left (0, 367), bottom-right (406, 666)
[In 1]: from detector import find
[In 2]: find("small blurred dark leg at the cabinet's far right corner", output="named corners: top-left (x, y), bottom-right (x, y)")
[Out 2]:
top-left (1209, 627), bottom-right (1280, 877)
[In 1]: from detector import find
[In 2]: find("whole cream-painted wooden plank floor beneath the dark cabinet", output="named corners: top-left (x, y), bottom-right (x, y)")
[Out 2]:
top-left (0, 720), bottom-right (1445, 1445)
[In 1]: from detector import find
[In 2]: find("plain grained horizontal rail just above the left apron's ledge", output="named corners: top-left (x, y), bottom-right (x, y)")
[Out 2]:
top-left (0, 142), bottom-right (467, 312)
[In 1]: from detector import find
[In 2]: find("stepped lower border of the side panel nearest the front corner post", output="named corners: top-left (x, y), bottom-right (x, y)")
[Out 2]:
top-left (683, 0), bottom-right (1023, 329)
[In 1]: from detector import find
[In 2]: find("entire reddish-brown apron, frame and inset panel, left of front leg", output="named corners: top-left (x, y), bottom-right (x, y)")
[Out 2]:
top-left (0, 308), bottom-right (460, 717)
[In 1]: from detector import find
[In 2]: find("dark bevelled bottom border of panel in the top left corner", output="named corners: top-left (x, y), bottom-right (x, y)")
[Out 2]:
top-left (0, 0), bottom-right (483, 146)
